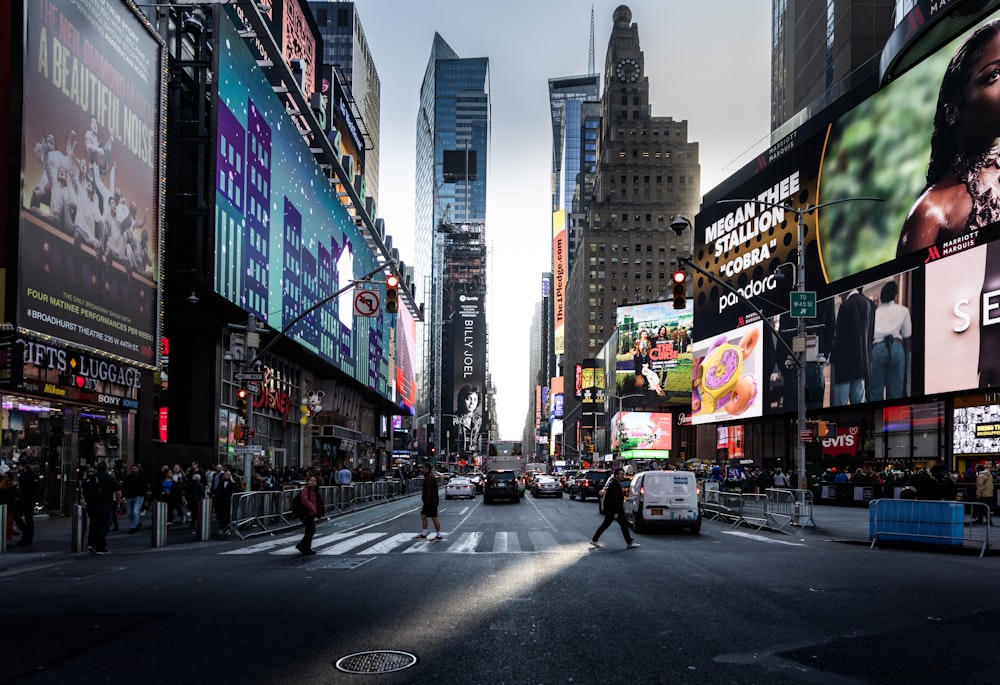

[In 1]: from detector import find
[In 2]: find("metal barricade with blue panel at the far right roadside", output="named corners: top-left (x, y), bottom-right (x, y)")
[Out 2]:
top-left (868, 499), bottom-right (991, 557)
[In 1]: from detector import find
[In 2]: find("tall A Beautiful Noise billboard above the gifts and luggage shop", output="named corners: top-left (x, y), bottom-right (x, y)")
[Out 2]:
top-left (17, 0), bottom-right (165, 365)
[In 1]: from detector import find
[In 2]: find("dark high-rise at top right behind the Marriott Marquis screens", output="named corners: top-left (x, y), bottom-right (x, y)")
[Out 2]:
top-left (771, 0), bottom-right (900, 131)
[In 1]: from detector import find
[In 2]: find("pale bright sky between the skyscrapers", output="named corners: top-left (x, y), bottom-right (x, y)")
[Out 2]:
top-left (355, 0), bottom-right (771, 440)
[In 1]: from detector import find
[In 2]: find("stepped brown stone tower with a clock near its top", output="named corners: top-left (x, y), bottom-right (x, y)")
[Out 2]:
top-left (556, 5), bottom-right (701, 454)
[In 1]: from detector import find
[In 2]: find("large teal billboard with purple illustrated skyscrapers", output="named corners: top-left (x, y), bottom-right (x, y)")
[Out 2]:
top-left (215, 13), bottom-right (395, 399)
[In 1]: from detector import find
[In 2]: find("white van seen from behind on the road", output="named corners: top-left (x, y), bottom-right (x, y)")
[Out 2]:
top-left (625, 471), bottom-right (701, 533)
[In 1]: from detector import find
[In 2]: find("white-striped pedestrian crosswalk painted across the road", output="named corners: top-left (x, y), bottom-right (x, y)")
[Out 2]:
top-left (220, 530), bottom-right (584, 556)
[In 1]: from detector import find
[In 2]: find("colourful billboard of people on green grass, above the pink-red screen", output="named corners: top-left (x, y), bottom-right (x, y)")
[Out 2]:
top-left (615, 302), bottom-right (693, 405)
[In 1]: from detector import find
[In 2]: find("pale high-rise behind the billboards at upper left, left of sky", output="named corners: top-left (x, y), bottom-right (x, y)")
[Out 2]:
top-left (309, 1), bottom-right (382, 206)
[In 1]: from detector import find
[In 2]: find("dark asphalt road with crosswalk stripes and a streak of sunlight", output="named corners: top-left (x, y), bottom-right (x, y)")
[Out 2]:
top-left (0, 496), bottom-right (1000, 685)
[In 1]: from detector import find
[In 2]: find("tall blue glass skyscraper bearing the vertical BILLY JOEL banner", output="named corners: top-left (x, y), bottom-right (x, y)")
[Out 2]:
top-left (414, 33), bottom-right (494, 459)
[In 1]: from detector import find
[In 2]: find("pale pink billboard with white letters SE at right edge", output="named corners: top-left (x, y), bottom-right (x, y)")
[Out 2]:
top-left (924, 243), bottom-right (1000, 394)
